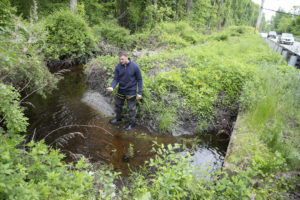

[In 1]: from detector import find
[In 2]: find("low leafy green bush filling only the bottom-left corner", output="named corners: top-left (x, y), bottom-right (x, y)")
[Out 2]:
top-left (0, 136), bottom-right (116, 199)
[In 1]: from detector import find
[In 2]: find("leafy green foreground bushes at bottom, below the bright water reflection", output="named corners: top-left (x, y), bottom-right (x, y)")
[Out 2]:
top-left (122, 144), bottom-right (289, 200)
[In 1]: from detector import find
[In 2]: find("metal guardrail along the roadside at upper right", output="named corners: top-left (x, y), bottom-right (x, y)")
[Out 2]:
top-left (263, 38), bottom-right (300, 69)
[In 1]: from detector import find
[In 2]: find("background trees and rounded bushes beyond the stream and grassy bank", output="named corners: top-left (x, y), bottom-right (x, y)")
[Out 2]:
top-left (3, 0), bottom-right (258, 63)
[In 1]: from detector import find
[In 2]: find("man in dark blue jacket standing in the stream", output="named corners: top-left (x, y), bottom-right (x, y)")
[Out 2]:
top-left (106, 51), bottom-right (143, 131)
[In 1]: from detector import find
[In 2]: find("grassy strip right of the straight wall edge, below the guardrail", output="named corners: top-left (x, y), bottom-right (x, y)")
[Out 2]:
top-left (227, 63), bottom-right (300, 177)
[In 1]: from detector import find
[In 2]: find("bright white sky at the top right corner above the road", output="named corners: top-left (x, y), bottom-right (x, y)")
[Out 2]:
top-left (252, 0), bottom-right (300, 20)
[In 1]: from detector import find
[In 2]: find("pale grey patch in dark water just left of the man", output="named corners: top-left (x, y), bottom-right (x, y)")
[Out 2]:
top-left (81, 91), bottom-right (115, 117)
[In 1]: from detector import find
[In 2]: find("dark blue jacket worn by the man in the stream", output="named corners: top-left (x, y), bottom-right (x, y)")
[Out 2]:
top-left (111, 59), bottom-right (143, 95)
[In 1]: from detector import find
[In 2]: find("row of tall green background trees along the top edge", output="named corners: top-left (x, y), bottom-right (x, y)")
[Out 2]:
top-left (12, 0), bottom-right (258, 31)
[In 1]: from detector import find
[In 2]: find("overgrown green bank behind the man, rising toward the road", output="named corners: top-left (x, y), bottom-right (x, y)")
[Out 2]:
top-left (86, 24), bottom-right (281, 133)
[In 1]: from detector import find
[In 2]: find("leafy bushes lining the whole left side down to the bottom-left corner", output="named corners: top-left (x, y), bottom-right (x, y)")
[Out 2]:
top-left (0, 10), bottom-right (117, 199)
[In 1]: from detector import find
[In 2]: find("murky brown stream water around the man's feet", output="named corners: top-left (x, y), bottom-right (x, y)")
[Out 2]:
top-left (27, 67), bottom-right (228, 175)
